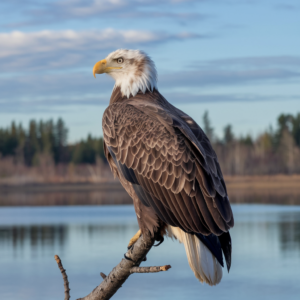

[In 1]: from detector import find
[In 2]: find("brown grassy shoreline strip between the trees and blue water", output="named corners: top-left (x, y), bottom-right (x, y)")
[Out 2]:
top-left (0, 175), bottom-right (300, 206)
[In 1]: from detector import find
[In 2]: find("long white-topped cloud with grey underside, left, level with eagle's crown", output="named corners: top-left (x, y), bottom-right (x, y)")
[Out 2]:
top-left (0, 28), bottom-right (201, 74)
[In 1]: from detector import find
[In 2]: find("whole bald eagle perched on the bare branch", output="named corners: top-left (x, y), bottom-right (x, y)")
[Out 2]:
top-left (93, 49), bottom-right (234, 285)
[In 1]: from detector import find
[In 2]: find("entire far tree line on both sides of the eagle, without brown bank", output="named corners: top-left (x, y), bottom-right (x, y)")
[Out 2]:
top-left (0, 112), bottom-right (300, 175)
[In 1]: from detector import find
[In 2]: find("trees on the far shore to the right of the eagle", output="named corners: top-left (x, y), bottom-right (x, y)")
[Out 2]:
top-left (203, 112), bottom-right (300, 175)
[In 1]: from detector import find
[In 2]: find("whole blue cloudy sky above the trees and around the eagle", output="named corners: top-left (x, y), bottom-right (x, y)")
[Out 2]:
top-left (0, 0), bottom-right (300, 142)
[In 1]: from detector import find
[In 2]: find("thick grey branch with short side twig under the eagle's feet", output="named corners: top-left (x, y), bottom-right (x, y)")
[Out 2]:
top-left (77, 235), bottom-right (171, 300)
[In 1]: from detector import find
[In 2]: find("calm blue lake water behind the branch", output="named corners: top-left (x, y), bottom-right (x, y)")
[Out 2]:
top-left (0, 204), bottom-right (300, 300)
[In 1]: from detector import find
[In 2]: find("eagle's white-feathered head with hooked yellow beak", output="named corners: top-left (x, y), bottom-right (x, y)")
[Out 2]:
top-left (93, 49), bottom-right (157, 98)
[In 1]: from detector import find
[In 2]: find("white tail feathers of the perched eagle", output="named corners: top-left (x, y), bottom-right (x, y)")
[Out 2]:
top-left (168, 225), bottom-right (223, 285)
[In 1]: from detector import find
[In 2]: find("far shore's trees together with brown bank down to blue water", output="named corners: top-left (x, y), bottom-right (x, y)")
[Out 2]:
top-left (0, 112), bottom-right (300, 206)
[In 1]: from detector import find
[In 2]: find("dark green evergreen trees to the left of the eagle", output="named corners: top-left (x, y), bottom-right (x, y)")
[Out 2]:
top-left (0, 118), bottom-right (104, 166)
